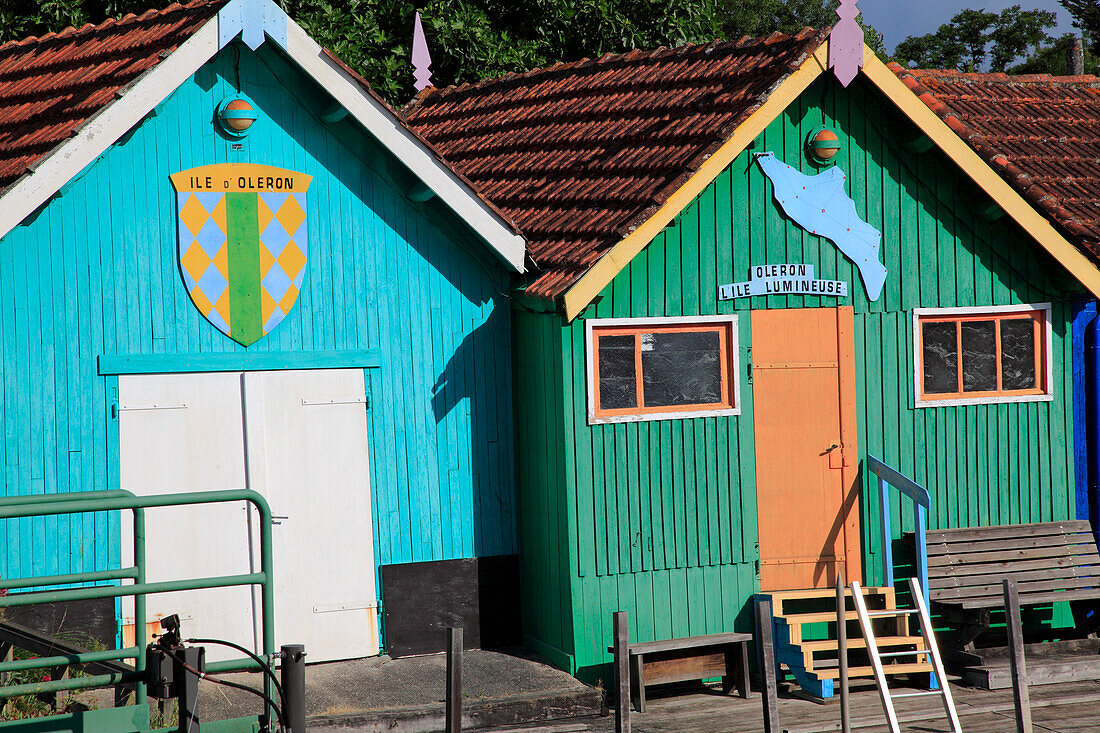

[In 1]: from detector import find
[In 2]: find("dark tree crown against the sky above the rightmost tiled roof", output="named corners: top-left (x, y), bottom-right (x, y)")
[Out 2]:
top-left (894, 6), bottom-right (1057, 72)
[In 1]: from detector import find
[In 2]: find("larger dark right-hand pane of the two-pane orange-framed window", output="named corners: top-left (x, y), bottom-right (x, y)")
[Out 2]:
top-left (641, 331), bottom-right (722, 407)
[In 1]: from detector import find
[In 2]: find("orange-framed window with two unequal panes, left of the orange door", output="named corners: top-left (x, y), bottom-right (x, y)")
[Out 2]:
top-left (587, 316), bottom-right (739, 423)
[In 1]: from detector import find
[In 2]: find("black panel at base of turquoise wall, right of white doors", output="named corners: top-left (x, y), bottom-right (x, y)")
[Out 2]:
top-left (380, 555), bottom-right (519, 657)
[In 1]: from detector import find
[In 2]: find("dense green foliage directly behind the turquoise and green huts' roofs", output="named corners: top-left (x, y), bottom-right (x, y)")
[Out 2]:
top-left (0, 0), bottom-right (882, 102)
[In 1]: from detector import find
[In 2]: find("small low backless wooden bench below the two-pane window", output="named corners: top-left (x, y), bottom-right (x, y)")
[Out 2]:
top-left (607, 633), bottom-right (752, 712)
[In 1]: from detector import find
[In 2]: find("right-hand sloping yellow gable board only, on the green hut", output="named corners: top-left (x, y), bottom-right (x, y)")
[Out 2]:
top-left (864, 46), bottom-right (1100, 297)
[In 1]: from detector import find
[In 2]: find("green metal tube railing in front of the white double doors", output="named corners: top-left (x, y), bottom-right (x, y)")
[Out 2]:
top-left (0, 489), bottom-right (275, 723)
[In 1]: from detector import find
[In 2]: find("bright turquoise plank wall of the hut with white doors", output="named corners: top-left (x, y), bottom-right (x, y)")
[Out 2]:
top-left (0, 44), bottom-right (515, 587)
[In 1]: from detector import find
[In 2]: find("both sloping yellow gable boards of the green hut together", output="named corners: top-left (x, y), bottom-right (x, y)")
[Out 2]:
top-left (562, 40), bottom-right (1100, 320)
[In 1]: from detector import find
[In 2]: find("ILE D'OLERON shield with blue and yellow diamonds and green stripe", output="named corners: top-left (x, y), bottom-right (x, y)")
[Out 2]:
top-left (169, 163), bottom-right (312, 347)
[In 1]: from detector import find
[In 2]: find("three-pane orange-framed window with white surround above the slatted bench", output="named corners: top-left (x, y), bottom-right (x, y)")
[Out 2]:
top-left (914, 304), bottom-right (1053, 406)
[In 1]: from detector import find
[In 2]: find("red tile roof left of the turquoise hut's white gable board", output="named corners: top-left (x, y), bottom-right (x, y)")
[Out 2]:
top-left (0, 0), bottom-right (227, 192)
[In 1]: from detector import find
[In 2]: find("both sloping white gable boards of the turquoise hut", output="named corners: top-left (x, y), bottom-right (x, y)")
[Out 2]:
top-left (0, 0), bottom-right (526, 272)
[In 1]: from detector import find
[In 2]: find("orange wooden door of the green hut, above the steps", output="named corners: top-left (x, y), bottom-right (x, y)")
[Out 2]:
top-left (752, 307), bottom-right (861, 590)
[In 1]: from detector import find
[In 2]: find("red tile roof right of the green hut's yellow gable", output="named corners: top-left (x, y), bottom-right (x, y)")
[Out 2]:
top-left (890, 64), bottom-right (1100, 264)
